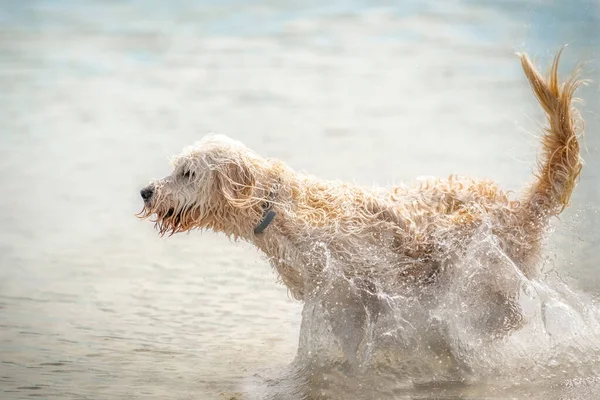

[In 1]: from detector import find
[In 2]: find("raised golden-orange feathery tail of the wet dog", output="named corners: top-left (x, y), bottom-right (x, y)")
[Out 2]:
top-left (518, 50), bottom-right (584, 219)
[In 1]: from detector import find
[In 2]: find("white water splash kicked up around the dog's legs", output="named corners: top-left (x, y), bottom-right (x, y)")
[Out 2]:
top-left (243, 220), bottom-right (600, 399)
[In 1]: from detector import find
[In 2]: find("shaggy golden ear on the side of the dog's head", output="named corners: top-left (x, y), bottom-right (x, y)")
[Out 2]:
top-left (217, 162), bottom-right (256, 207)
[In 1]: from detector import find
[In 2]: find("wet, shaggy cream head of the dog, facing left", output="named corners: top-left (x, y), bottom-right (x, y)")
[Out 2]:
top-left (138, 134), bottom-right (276, 237)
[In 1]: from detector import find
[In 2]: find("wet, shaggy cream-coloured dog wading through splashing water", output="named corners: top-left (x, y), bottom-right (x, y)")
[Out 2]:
top-left (138, 51), bottom-right (583, 360)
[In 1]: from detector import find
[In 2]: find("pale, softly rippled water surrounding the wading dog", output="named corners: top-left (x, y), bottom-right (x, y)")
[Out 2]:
top-left (0, 0), bottom-right (600, 399)
